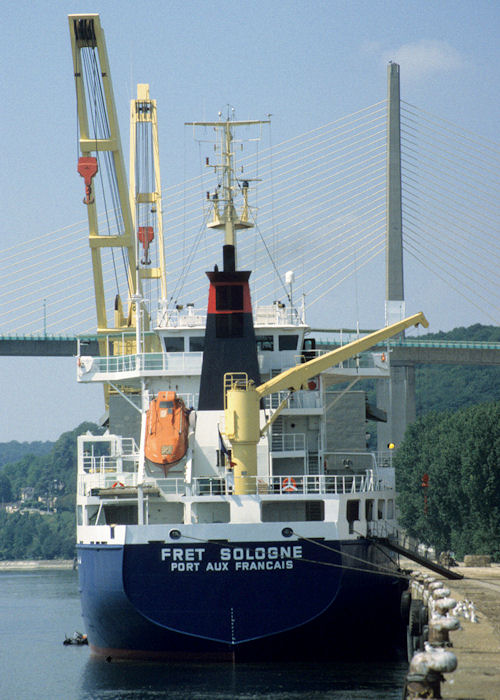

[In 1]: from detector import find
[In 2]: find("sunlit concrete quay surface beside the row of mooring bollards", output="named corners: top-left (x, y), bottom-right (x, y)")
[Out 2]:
top-left (403, 561), bottom-right (500, 700)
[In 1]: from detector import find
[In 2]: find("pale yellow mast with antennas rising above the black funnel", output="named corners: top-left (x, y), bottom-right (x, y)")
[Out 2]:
top-left (186, 119), bottom-right (269, 266)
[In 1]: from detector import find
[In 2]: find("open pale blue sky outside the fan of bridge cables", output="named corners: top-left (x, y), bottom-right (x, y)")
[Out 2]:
top-left (0, 0), bottom-right (500, 441)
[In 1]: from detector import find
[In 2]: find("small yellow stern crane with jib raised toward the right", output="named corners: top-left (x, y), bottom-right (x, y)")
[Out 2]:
top-left (224, 312), bottom-right (429, 495)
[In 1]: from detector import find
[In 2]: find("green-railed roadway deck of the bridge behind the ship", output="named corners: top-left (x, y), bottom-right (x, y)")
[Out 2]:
top-left (0, 335), bottom-right (500, 367)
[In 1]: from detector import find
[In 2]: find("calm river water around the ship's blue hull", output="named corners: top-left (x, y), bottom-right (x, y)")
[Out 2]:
top-left (0, 570), bottom-right (407, 700)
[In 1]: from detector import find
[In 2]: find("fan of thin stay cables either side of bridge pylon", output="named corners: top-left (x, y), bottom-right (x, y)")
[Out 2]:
top-left (0, 95), bottom-right (500, 338)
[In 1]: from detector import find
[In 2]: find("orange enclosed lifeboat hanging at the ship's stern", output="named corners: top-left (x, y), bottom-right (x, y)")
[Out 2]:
top-left (144, 391), bottom-right (189, 474)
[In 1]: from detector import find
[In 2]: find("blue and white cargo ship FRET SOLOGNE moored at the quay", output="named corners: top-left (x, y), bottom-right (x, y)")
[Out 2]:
top-left (69, 15), bottom-right (427, 661)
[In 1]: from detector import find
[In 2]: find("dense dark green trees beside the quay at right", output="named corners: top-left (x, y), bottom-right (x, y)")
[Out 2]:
top-left (395, 403), bottom-right (500, 558)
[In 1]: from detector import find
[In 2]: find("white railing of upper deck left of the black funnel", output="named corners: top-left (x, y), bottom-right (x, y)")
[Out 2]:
top-left (78, 352), bottom-right (203, 380)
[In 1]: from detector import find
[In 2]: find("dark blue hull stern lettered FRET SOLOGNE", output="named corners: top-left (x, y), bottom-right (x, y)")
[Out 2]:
top-left (78, 540), bottom-right (406, 660)
